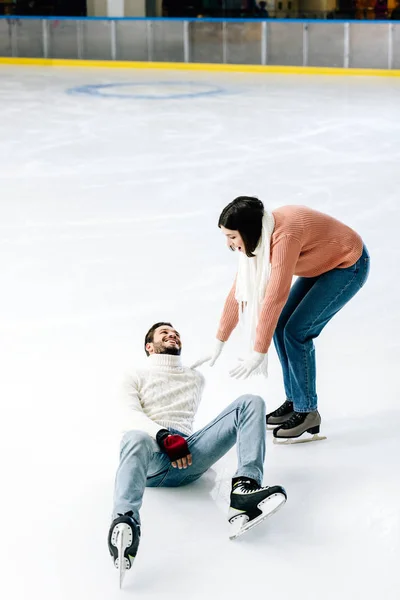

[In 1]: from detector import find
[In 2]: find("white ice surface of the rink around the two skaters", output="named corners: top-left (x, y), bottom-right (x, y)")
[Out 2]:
top-left (0, 66), bottom-right (400, 600)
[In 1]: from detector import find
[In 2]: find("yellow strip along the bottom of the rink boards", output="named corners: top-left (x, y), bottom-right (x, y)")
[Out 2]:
top-left (0, 57), bottom-right (400, 77)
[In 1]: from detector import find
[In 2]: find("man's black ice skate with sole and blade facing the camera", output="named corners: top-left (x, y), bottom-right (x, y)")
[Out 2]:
top-left (108, 512), bottom-right (140, 587)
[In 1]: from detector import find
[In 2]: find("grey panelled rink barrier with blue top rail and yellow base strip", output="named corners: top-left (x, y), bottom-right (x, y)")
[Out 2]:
top-left (0, 16), bottom-right (400, 76)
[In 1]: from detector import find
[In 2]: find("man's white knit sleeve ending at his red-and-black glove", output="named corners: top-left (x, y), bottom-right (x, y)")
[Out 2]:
top-left (121, 374), bottom-right (165, 440)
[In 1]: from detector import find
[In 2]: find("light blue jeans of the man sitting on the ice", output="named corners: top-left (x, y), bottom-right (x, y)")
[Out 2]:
top-left (112, 395), bottom-right (266, 523)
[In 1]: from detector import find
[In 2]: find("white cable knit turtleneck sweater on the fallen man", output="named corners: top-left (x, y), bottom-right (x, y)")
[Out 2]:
top-left (124, 354), bottom-right (204, 439)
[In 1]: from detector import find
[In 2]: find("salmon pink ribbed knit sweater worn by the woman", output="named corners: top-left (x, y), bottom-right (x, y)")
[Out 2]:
top-left (217, 206), bottom-right (363, 353)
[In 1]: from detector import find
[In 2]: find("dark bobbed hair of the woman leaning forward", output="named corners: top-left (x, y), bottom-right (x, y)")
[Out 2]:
top-left (218, 196), bottom-right (264, 257)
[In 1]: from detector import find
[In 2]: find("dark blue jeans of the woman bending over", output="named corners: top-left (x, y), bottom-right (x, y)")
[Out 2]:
top-left (274, 246), bottom-right (369, 412)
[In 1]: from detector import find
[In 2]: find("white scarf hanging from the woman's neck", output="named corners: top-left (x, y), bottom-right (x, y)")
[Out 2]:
top-left (235, 211), bottom-right (275, 377)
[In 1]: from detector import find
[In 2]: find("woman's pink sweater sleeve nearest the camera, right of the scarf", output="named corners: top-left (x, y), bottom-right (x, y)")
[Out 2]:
top-left (254, 235), bottom-right (301, 353)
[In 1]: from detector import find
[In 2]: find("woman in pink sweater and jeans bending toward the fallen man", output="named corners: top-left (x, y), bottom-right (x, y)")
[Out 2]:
top-left (195, 196), bottom-right (369, 441)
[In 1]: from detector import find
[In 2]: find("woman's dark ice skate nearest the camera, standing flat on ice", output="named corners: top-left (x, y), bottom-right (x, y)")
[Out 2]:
top-left (273, 410), bottom-right (326, 444)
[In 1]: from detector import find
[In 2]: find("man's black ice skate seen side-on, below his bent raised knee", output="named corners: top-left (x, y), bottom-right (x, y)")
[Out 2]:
top-left (228, 478), bottom-right (287, 540)
